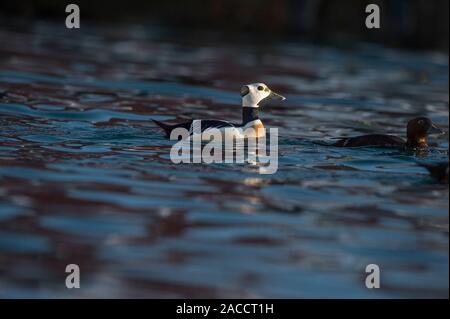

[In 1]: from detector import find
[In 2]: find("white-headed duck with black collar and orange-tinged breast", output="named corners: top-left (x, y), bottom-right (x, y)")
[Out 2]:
top-left (153, 83), bottom-right (286, 139)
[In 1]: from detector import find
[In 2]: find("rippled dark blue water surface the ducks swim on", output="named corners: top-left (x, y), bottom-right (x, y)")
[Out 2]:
top-left (0, 25), bottom-right (449, 298)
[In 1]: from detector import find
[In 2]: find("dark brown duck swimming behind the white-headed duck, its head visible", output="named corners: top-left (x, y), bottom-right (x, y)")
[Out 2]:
top-left (333, 117), bottom-right (445, 148)
